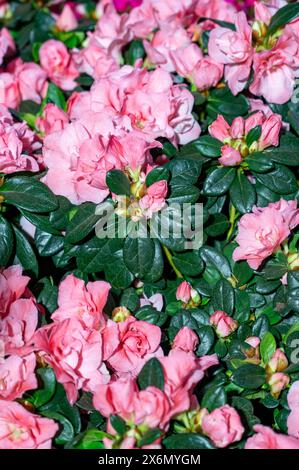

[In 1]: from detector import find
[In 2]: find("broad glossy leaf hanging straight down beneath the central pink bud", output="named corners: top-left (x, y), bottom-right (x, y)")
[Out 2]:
top-left (124, 237), bottom-right (155, 279)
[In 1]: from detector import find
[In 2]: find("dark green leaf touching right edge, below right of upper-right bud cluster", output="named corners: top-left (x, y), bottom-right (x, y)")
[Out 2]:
top-left (255, 165), bottom-right (298, 194)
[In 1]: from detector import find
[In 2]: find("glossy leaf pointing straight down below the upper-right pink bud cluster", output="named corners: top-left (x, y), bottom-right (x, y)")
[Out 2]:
top-left (229, 171), bottom-right (256, 214)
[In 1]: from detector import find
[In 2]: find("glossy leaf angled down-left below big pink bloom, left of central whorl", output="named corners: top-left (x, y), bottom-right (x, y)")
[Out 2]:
top-left (65, 202), bottom-right (100, 244)
